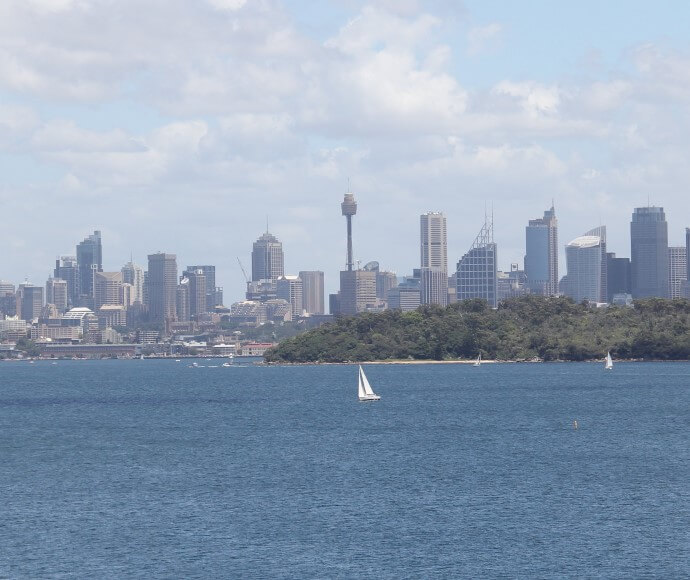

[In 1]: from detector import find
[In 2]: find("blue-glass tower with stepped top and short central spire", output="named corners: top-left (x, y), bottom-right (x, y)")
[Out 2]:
top-left (525, 205), bottom-right (558, 296)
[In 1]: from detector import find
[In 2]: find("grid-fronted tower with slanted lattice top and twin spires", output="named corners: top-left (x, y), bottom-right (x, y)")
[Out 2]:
top-left (455, 219), bottom-right (498, 308)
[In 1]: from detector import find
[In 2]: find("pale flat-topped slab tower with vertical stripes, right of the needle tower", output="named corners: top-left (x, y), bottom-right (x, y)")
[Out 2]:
top-left (419, 212), bottom-right (448, 306)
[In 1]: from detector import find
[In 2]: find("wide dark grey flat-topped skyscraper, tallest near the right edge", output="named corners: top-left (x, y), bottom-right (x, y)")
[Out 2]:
top-left (630, 206), bottom-right (668, 298)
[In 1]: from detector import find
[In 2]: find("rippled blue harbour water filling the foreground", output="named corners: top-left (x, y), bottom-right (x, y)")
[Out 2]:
top-left (0, 360), bottom-right (690, 578)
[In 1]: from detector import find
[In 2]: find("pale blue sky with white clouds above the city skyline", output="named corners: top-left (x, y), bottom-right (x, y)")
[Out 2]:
top-left (0, 0), bottom-right (690, 304)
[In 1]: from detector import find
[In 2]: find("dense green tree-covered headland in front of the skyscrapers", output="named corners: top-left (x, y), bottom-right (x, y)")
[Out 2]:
top-left (266, 296), bottom-right (690, 362)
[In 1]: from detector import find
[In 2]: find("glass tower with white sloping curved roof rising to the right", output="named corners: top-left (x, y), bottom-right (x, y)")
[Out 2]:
top-left (561, 226), bottom-right (607, 303)
